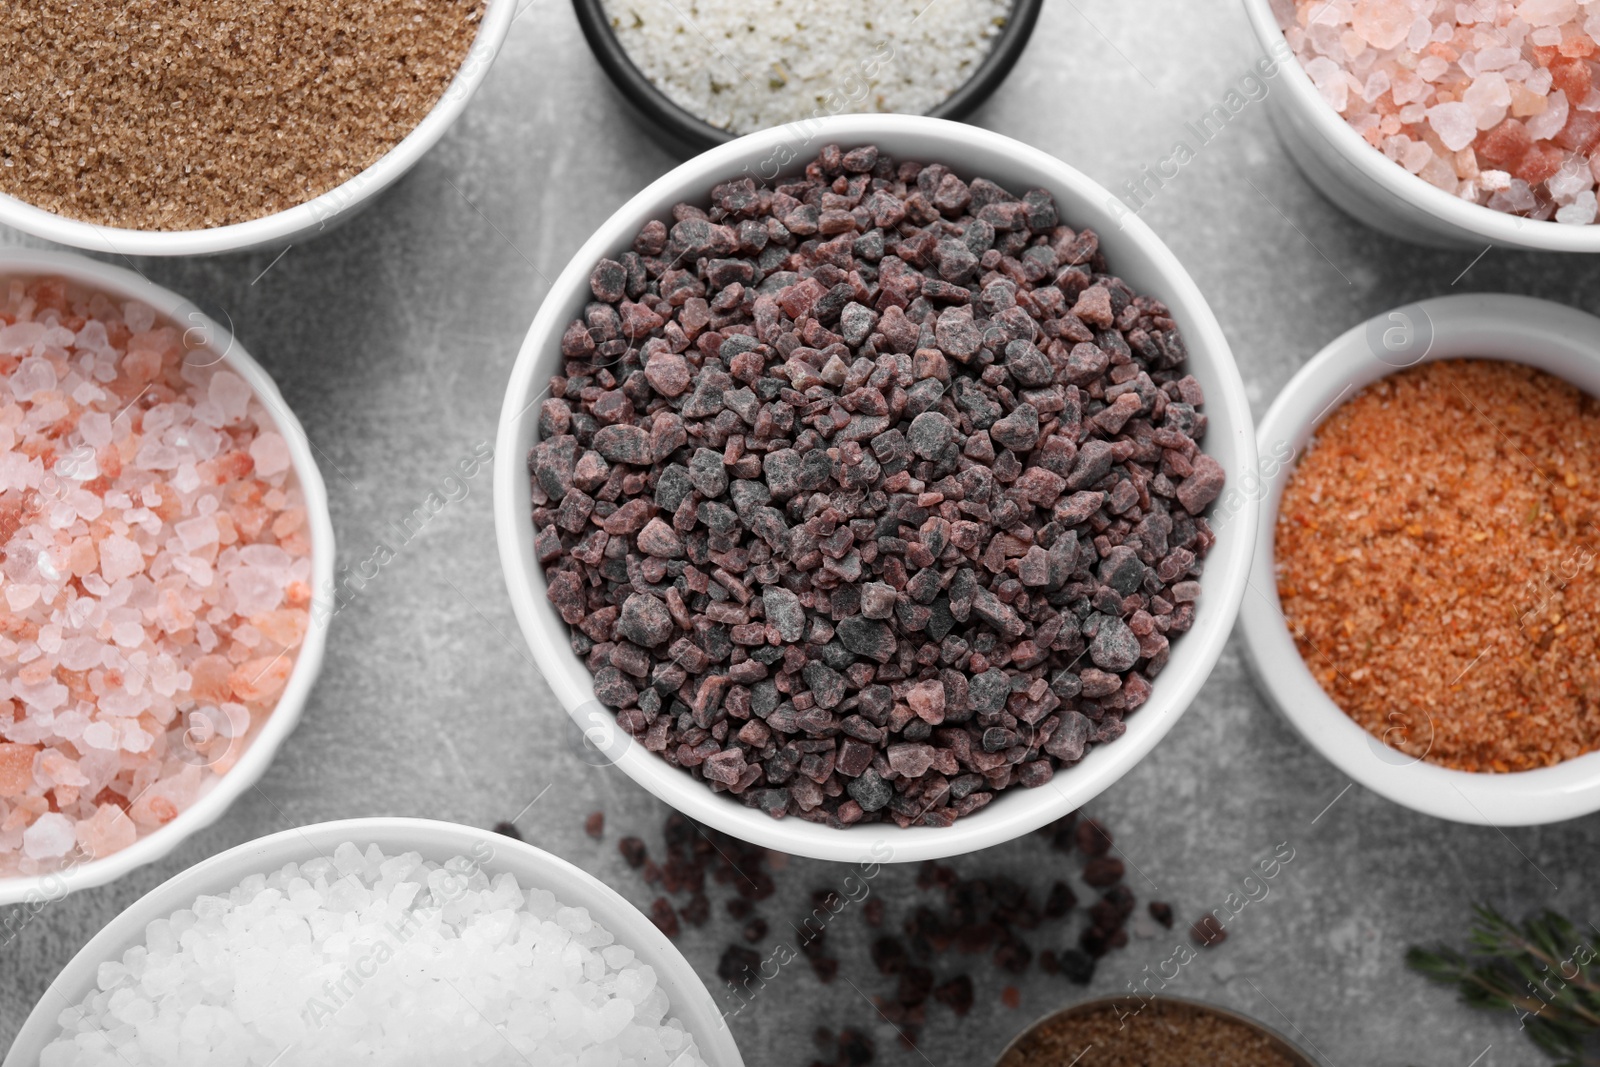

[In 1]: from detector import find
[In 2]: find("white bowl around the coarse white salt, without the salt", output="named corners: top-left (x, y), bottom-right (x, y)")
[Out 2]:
top-left (3, 819), bottom-right (744, 1067)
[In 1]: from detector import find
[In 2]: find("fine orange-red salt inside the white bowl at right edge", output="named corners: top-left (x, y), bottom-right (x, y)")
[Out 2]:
top-left (1277, 360), bottom-right (1600, 771)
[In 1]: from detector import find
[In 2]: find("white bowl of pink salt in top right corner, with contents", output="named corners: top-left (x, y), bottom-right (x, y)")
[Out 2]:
top-left (1245, 0), bottom-right (1600, 251)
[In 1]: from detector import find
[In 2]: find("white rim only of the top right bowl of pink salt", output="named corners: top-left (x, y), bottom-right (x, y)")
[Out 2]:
top-left (1243, 0), bottom-right (1600, 253)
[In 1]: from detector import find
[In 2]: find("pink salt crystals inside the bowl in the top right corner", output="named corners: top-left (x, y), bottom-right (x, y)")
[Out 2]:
top-left (1274, 0), bottom-right (1600, 226)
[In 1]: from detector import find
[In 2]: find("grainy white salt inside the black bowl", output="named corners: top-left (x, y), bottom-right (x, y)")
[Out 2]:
top-left (603, 0), bottom-right (1011, 133)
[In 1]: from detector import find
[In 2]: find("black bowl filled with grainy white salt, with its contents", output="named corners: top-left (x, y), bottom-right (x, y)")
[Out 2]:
top-left (573, 0), bottom-right (1043, 156)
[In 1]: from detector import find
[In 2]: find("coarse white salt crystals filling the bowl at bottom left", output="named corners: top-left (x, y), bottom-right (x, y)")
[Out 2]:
top-left (38, 843), bottom-right (704, 1067)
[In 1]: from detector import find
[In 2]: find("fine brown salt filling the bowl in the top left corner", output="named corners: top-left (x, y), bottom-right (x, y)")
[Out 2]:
top-left (0, 0), bottom-right (485, 230)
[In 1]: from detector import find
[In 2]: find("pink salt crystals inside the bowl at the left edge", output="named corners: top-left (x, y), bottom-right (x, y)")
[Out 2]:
top-left (0, 280), bottom-right (312, 877)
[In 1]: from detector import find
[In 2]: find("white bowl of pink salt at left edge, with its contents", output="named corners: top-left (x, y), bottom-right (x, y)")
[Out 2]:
top-left (0, 250), bottom-right (333, 910)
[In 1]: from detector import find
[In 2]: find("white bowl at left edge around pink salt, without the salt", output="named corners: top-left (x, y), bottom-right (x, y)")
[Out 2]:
top-left (0, 250), bottom-right (333, 904)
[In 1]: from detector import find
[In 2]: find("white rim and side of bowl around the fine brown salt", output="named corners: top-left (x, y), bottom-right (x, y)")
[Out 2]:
top-left (0, 0), bottom-right (517, 256)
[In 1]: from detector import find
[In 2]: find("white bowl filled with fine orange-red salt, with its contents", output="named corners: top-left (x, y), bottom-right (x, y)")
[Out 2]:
top-left (1242, 294), bottom-right (1600, 825)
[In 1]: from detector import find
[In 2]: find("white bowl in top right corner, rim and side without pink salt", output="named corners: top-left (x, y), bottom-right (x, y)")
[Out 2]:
top-left (1245, 0), bottom-right (1600, 251)
